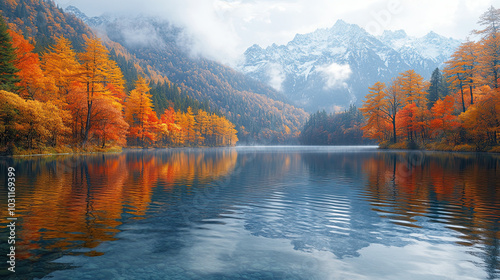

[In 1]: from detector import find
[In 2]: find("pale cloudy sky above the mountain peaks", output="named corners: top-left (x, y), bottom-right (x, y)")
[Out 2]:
top-left (55, 0), bottom-right (500, 65)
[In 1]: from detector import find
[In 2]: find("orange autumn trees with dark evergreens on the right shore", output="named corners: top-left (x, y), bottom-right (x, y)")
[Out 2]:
top-left (360, 7), bottom-right (500, 151)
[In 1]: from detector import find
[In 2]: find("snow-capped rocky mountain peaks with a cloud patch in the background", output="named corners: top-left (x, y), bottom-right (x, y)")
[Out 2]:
top-left (238, 20), bottom-right (460, 112)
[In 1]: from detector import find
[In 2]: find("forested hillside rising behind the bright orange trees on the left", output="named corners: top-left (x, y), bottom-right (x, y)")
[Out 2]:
top-left (0, 0), bottom-right (308, 151)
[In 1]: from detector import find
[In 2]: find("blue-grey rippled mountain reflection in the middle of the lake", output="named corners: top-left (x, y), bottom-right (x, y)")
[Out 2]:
top-left (234, 150), bottom-right (398, 258)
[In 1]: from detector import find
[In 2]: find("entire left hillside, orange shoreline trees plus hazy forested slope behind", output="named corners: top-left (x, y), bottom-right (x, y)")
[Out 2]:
top-left (0, 0), bottom-right (307, 155)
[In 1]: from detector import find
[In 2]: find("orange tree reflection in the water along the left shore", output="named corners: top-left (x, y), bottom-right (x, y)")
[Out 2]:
top-left (0, 149), bottom-right (237, 276)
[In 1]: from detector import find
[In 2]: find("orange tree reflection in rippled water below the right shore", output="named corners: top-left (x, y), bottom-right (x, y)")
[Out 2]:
top-left (364, 152), bottom-right (500, 279)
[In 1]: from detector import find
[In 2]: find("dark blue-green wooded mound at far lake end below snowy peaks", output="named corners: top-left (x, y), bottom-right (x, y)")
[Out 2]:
top-left (299, 106), bottom-right (373, 145)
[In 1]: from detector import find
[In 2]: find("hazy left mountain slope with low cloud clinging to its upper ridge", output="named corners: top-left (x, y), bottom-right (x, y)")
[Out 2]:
top-left (66, 7), bottom-right (307, 144)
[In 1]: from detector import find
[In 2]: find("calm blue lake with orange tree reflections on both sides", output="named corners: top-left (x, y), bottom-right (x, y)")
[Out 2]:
top-left (0, 147), bottom-right (500, 280)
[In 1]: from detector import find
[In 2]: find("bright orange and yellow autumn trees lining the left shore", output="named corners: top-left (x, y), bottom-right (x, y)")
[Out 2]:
top-left (0, 14), bottom-right (237, 153)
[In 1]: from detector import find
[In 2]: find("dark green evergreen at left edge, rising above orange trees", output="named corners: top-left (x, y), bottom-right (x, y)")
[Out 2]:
top-left (0, 15), bottom-right (20, 91)
